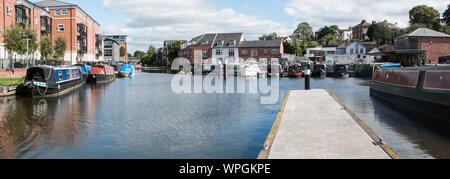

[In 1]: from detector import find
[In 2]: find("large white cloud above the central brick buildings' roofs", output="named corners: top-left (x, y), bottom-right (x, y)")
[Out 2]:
top-left (103, 0), bottom-right (292, 52)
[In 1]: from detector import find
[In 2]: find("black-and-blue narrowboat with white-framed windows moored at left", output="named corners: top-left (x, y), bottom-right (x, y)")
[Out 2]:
top-left (17, 65), bottom-right (84, 97)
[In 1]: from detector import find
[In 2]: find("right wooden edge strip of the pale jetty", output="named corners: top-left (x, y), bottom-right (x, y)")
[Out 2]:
top-left (326, 89), bottom-right (402, 159)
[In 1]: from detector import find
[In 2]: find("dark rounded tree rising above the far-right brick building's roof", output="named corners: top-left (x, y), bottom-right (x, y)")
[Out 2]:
top-left (409, 5), bottom-right (441, 30)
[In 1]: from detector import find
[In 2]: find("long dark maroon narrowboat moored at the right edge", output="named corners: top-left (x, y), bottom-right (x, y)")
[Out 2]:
top-left (370, 66), bottom-right (450, 122)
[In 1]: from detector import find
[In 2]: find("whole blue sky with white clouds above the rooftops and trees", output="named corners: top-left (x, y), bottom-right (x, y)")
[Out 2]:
top-left (32, 0), bottom-right (450, 53)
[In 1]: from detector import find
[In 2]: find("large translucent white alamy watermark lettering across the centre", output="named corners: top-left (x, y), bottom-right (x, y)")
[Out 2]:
top-left (171, 58), bottom-right (280, 104)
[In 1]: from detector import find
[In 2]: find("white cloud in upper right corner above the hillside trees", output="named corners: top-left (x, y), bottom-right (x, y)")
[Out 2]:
top-left (284, 0), bottom-right (450, 30)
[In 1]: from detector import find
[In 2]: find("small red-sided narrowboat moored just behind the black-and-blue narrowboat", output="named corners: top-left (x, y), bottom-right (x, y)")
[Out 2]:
top-left (88, 64), bottom-right (116, 83)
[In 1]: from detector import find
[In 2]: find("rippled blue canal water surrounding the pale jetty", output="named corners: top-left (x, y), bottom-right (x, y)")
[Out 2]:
top-left (0, 73), bottom-right (450, 159)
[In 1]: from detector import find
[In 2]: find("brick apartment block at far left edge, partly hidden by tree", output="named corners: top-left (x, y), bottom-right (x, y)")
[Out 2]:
top-left (0, 0), bottom-right (52, 68)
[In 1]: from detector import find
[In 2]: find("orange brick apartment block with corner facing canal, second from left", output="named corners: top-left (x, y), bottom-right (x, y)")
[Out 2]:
top-left (36, 0), bottom-right (103, 64)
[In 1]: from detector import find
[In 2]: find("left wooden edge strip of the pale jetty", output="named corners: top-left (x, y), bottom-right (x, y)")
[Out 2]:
top-left (257, 90), bottom-right (291, 159)
